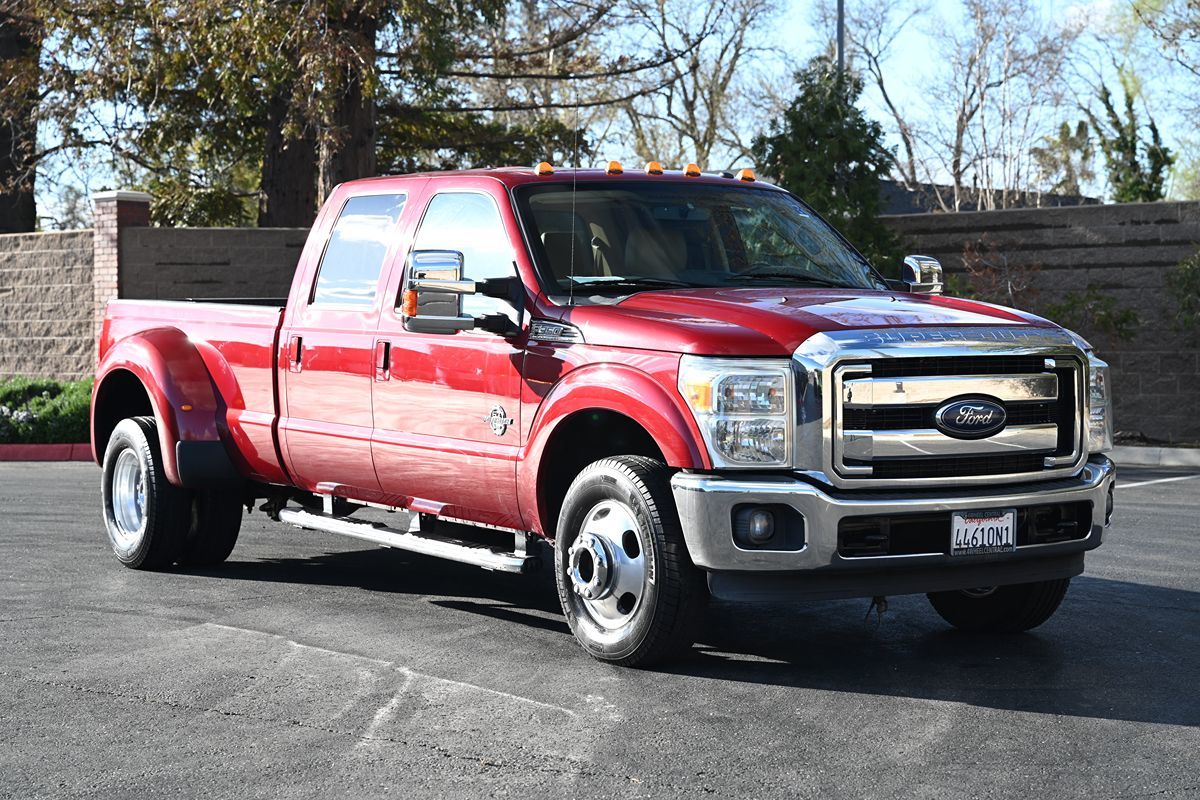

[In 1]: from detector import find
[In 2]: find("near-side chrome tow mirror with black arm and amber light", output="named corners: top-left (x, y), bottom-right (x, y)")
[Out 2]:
top-left (401, 249), bottom-right (524, 336)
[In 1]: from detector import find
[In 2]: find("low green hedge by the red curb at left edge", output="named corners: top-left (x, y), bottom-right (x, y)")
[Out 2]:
top-left (0, 378), bottom-right (91, 444)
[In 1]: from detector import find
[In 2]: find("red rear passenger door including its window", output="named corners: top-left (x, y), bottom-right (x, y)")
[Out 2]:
top-left (281, 192), bottom-right (407, 498)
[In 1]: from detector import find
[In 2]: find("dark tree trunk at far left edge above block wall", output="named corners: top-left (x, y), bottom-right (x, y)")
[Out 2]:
top-left (0, 10), bottom-right (41, 234)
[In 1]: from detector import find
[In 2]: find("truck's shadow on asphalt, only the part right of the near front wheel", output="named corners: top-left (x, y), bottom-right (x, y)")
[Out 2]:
top-left (674, 577), bottom-right (1200, 726)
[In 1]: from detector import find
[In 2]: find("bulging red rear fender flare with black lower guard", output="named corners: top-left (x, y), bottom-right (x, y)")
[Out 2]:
top-left (90, 327), bottom-right (241, 488)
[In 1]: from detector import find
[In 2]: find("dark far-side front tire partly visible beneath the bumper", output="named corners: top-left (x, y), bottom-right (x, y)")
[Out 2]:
top-left (928, 578), bottom-right (1070, 633)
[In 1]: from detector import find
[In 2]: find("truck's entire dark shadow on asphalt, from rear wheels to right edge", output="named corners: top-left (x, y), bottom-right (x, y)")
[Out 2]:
top-left (194, 549), bottom-right (1200, 726)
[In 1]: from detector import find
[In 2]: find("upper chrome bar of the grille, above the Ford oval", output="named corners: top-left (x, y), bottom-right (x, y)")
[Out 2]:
top-left (841, 372), bottom-right (1058, 408)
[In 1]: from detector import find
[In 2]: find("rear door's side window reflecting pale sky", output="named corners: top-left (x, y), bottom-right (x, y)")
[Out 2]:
top-left (312, 194), bottom-right (406, 306)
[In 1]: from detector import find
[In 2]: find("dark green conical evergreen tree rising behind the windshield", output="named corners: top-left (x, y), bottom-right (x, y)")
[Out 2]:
top-left (754, 56), bottom-right (901, 276)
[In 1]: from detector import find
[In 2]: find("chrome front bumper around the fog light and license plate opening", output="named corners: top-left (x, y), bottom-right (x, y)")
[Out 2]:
top-left (671, 457), bottom-right (1116, 596)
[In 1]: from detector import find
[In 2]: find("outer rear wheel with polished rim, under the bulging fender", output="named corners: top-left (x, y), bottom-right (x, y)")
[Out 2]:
top-left (101, 416), bottom-right (192, 570)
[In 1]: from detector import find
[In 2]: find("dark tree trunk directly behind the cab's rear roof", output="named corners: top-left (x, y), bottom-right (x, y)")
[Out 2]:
top-left (320, 10), bottom-right (378, 203)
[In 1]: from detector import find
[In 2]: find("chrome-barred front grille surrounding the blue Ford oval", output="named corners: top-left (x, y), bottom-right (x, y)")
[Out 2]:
top-left (829, 355), bottom-right (1084, 482)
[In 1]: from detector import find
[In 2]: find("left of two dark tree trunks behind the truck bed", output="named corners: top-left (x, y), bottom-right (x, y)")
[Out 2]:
top-left (258, 91), bottom-right (317, 228)
